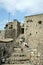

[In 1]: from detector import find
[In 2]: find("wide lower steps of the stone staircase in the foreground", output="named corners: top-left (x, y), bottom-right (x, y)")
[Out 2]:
top-left (2, 48), bottom-right (31, 65)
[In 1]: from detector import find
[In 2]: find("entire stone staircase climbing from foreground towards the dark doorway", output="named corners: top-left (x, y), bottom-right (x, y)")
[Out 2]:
top-left (2, 35), bottom-right (33, 65)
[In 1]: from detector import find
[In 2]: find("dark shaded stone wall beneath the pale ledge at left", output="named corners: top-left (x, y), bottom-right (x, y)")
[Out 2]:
top-left (0, 41), bottom-right (14, 57)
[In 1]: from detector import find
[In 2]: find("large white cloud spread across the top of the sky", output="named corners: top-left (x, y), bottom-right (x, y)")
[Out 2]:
top-left (0, 0), bottom-right (43, 13)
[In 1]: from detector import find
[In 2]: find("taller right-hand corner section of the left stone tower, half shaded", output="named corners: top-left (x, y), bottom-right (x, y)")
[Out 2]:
top-left (13, 19), bottom-right (21, 38)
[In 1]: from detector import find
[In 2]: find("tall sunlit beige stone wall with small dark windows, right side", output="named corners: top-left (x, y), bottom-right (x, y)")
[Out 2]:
top-left (24, 14), bottom-right (43, 48)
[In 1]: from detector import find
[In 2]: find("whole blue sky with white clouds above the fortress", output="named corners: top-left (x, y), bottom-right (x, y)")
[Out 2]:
top-left (0, 0), bottom-right (43, 30)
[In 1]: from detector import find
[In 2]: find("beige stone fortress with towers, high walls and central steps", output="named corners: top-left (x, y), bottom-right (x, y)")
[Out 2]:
top-left (0, 14), bottom-right (43, 65)
